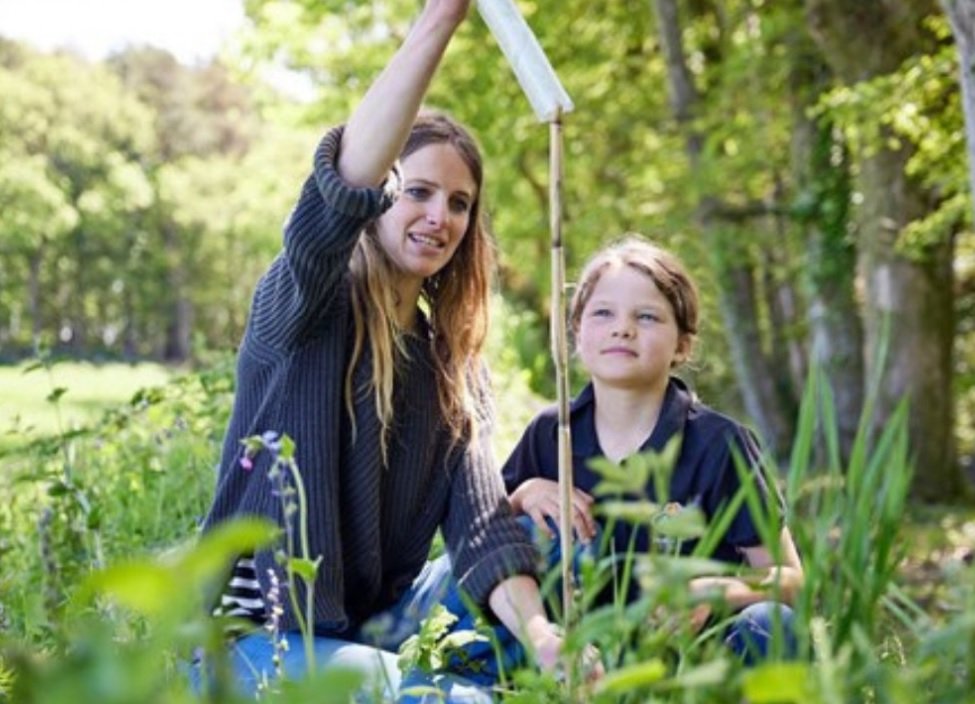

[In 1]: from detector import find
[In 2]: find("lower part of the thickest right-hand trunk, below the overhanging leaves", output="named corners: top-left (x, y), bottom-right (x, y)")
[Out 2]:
top-left (859, 150), bottom-right (962, 501)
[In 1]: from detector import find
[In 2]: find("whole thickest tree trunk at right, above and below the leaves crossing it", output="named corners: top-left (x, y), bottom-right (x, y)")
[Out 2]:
top-left (806, 0), bottom-right (962, 500)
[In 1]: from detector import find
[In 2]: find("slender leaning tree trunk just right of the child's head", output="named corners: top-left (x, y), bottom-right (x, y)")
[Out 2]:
top-left (654, 0), bottom-right (793, 458)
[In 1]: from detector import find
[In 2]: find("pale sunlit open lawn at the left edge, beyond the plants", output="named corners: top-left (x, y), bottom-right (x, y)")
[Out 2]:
top-left (0, 362), bottom-right (173, 448)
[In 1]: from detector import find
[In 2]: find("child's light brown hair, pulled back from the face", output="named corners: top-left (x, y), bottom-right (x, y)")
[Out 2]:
top-left (569, 233), bottom-right (698, 361)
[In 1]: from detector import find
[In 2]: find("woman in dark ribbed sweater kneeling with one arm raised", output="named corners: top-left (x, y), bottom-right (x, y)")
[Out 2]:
top-left (205, 0), bottom-right (561, 701)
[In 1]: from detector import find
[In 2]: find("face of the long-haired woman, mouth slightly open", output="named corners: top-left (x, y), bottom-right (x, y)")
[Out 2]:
top-left (376, 142), bottom-right (477, 294)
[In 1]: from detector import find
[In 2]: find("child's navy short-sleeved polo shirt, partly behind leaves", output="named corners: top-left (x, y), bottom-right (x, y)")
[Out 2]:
top-left (502, 377), bottom-right (769, 563)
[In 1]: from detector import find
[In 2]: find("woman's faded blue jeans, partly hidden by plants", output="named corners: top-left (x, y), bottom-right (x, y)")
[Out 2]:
top-left (189, 557), bottom-right (493, 704)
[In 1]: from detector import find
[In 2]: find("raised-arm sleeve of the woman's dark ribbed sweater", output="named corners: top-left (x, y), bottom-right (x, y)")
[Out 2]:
top-left (245, 126), bottom-right (399, 352)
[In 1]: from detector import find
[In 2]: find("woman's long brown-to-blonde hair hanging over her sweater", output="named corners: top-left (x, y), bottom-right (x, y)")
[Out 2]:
top-left (345, 113), bottom-right (495, 459)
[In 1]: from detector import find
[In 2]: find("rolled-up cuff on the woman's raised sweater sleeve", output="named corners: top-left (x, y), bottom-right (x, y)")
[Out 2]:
top-left (314, 125), bottom-right (402, 220)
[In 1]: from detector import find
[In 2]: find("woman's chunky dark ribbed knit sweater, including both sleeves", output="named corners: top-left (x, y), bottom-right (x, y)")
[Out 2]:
top-left (204, 127), bottom-right (536, 635)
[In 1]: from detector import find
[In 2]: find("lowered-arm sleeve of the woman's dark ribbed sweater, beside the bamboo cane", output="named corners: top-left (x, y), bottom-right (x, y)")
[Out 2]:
top-left (441, 376), bottom-right (540, 605)
